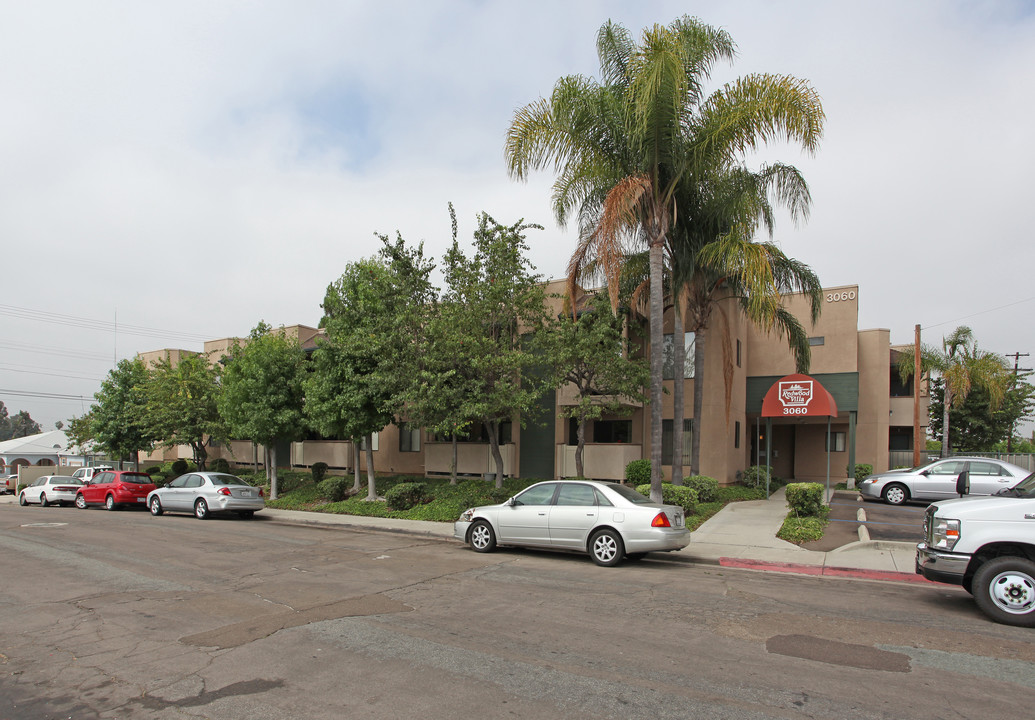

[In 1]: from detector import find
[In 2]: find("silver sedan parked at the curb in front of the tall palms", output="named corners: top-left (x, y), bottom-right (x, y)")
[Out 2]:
top-left (453, 480), bottom-right (690, 566)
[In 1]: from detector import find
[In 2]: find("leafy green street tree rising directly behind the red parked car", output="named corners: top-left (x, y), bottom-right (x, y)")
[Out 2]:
top-left (91, 358), bottom-right (155, 470)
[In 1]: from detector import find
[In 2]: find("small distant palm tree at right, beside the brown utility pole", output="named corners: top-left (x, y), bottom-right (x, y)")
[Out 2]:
top-left (898, 325), bottom-right (1012, 457)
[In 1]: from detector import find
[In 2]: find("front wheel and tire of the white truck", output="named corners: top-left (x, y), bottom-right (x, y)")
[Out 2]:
top-left (973, 556), bottom-right (1035, 628)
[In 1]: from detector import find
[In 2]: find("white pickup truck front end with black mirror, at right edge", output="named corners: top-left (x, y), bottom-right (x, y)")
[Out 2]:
top-left (916, 473), bottom-right (1035, 628)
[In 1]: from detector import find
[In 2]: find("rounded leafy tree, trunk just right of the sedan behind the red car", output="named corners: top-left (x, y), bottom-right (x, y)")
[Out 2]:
top-left (216, 323), bottom-right (305, 500)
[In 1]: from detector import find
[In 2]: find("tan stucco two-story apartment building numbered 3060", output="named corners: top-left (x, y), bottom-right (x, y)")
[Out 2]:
top-left (141, 281), bottom-right (927, 483)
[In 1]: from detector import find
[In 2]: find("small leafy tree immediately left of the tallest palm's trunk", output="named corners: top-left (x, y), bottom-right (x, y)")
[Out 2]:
top-left (544, 296), bottom-right (650, 477)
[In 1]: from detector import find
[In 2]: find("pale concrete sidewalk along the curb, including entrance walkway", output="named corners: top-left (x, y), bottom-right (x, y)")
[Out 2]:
top-left (262, 487), bottom-right (926, 582)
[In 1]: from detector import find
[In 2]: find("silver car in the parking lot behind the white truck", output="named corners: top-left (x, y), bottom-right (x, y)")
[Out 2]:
top-left (859, 457), bottom-right (1030, 505)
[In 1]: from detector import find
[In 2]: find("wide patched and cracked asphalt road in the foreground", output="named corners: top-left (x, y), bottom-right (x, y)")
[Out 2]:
top-left (0, 505), bottom-right (1035, 720)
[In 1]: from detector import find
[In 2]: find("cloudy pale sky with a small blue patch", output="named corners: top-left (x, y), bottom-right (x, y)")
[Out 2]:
top-left (0, 0), bottom-right (1035, 429)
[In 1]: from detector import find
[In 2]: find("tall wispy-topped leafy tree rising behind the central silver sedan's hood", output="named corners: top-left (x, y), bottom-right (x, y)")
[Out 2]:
top-left (443, 213), bottom-right (553, 487)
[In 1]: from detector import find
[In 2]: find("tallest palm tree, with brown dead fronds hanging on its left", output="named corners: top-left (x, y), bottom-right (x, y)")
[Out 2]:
top-left (505, 17), bottom-right (823, 500)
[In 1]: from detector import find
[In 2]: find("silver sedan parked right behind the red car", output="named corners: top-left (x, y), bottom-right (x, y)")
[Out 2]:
top-left (147, 472), bottom-right (266, 519)
